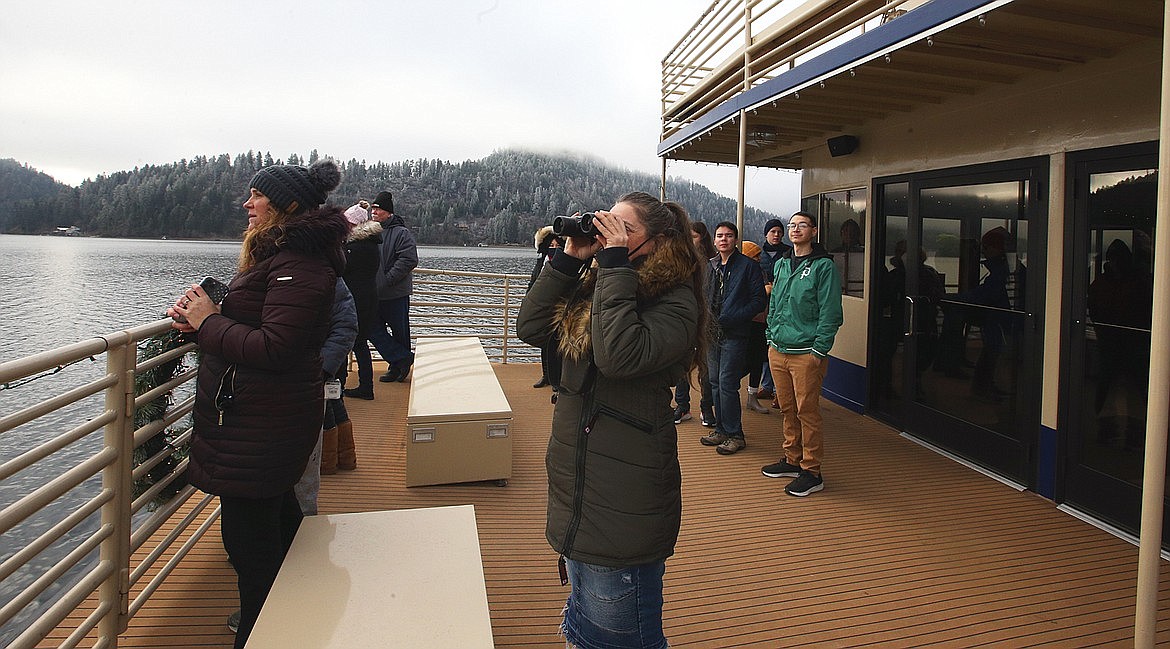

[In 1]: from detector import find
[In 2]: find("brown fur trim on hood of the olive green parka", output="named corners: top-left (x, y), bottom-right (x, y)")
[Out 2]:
top-left (552, 246), bottom-right (695, 360)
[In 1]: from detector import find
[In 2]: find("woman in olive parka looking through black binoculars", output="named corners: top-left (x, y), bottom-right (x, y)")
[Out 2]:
top-left (516, 192), bottom-right (707, 649)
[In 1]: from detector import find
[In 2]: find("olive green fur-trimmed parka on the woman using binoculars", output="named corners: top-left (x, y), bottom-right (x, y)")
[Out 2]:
top-left (516, 247), bottom-right (700, 567)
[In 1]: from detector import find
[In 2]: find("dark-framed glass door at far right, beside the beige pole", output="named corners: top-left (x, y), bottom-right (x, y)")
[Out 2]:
top-left (1061, 144), bottom-right (1170, 541)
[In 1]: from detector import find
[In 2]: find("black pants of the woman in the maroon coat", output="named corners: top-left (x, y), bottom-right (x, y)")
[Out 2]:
top-left (220, 489), bottom-right (302, 649)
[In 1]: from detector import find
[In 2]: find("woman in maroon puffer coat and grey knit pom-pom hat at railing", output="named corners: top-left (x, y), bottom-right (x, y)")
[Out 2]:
top-left (167, 160), bottom-right (349, 648)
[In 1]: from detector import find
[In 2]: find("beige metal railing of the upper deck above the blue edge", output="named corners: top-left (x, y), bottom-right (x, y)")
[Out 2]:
top-left (659, 0), bottom-right (925, 140)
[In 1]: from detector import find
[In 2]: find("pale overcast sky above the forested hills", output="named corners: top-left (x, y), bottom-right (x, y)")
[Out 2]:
top-left (0, 0), bottom-right (799, 213)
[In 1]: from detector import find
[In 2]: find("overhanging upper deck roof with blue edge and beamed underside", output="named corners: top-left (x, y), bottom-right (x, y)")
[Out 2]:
top-left (658, 0), bottom-right (1163, 168)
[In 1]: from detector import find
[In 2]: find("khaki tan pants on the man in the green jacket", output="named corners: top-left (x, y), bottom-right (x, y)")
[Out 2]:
top-left (768, 347), bottom-right (828, 476)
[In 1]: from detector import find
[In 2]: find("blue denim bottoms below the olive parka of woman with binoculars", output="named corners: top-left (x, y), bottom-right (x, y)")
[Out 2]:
top-left (560, 559), bottom-right (669, 649)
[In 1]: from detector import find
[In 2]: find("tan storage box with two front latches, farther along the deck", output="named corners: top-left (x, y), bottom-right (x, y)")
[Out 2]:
top-left (406, 338), bottom-right (511, 486)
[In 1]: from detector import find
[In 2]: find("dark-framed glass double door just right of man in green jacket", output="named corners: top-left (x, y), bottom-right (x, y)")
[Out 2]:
top-left (870, 164), bottom-right (1044, 484)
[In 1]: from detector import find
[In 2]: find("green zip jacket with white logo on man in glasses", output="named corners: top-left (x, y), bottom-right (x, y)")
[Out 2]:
top-left (768, 243), bottom-right (844, 358)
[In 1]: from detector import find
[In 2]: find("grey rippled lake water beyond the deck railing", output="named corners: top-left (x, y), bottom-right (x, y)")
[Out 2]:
top-left (0, 235), bottom-right (536, 647)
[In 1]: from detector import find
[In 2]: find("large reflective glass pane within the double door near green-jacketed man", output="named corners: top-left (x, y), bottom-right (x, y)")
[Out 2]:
top-left (914, 181), bottom-right (1027, 437)
